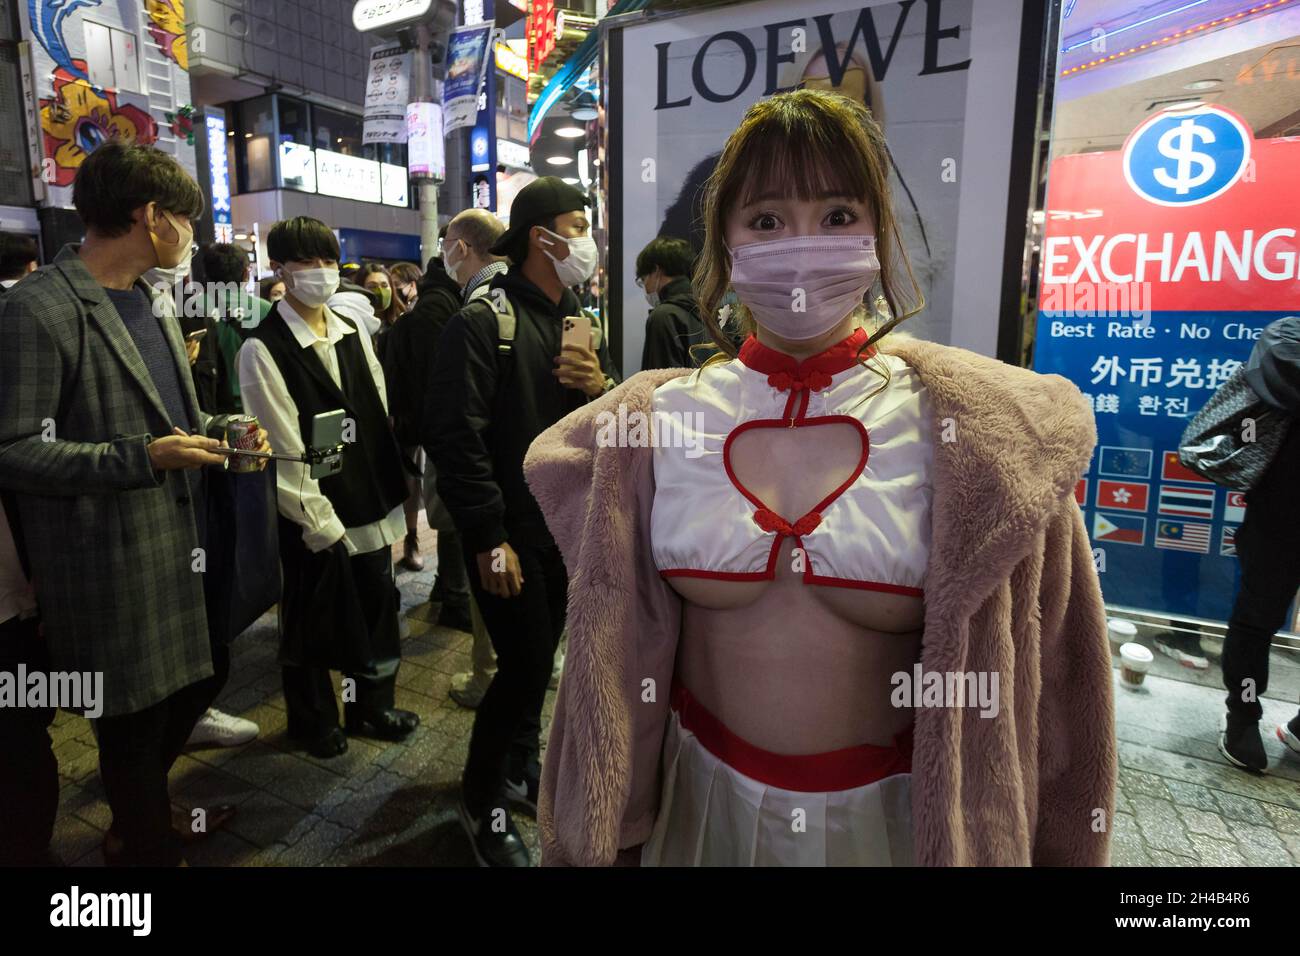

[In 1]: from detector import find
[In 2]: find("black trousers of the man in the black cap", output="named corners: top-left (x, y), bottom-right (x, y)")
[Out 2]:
top-left (462, 544), bottom-right (568, 816)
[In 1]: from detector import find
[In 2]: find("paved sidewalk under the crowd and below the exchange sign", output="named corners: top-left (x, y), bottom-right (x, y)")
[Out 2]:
top-left (40, 522), bottom-right (1300, 866)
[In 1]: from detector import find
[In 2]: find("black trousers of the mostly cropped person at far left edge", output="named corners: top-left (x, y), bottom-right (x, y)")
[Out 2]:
top-left (0, 618), bottom-right (59, 866)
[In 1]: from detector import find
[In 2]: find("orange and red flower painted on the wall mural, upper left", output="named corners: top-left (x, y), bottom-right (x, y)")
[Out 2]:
top-left (40, 60), bottom-right (159, 186)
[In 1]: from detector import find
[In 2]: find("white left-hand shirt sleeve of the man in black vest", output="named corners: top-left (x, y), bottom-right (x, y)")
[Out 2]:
top-left (238, 338), bottom-right (345, 551)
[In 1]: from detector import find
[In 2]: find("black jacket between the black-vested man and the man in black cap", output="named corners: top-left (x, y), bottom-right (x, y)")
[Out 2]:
top-left (382, 269), bottom-right (460, 449)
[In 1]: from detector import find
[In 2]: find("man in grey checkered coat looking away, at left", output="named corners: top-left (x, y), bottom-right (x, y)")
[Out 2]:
top-left (0, 142), bottom-right (265, 865)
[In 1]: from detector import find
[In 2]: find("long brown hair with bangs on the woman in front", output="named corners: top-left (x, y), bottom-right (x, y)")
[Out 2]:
top-left (692, 90), bottom-right (924, 360)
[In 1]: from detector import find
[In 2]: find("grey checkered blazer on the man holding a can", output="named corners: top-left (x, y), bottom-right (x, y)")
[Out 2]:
top-left (0, 246), bottom-right (212, 717)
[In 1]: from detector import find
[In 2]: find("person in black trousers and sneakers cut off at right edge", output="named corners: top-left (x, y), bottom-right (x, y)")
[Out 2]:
top-left (1219, 316), bottom-right (1300, 771)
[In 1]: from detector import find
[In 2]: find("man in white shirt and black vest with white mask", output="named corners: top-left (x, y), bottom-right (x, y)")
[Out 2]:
top-left (239, 216), bottom-right (420, 757)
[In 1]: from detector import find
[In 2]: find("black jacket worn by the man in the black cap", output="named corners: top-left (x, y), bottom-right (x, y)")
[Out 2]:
top-left (418, 267), bottom-right (619, 553)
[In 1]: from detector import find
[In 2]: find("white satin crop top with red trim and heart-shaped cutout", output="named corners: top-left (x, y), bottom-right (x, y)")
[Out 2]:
top-left (650, 329), bottom-right (933, 597)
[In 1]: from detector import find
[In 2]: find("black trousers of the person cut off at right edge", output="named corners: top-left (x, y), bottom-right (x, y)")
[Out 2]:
top-left (1223, 424), bottom-right (1300, 721)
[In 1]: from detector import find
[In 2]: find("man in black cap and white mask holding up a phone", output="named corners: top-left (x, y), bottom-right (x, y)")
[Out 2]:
top-left (424, 176), bottom-right (618, 866)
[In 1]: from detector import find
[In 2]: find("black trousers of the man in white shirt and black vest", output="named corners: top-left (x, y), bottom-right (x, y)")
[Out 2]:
top-left (281, 548), bottom-right (402, 740)
